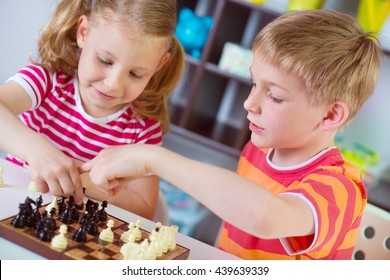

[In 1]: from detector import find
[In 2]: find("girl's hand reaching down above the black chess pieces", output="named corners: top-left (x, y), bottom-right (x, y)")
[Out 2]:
top-left (27, 145), bottom-right (83, 204)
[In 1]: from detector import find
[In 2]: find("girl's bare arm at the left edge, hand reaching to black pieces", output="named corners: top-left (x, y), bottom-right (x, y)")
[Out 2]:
top-left (0, 81), bottom-right (83, 203)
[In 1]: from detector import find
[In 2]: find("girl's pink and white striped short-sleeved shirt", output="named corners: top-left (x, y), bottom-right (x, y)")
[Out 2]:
top-left (8, 65), bottom-right (162, 166)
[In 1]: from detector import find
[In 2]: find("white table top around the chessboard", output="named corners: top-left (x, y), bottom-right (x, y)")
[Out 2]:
top-left (0, 158), bottom-right (238, 260)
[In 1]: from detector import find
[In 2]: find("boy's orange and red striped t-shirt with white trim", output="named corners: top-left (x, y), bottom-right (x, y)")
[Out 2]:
top-left (220, 142), bottom-right (367, 259)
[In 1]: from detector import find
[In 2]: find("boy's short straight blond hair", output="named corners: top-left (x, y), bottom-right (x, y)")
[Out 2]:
top-left (253, 10), bottom-right (381, 123)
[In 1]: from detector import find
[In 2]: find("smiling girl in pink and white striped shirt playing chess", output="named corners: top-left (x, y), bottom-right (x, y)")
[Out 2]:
top-left (0, 0), bottom-right (184, 218)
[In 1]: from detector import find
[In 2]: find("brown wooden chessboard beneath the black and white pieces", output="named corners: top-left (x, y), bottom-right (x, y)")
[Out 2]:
top-left (0, 195), bottom-right (190, 260)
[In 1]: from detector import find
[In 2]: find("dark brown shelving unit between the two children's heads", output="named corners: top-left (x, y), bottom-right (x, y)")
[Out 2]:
top-left (170, 0), bottom-right (279, 156)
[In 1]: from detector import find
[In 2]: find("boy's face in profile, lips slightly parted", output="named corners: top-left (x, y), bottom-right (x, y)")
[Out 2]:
top-left (244, 53), bottom-right (328, 156)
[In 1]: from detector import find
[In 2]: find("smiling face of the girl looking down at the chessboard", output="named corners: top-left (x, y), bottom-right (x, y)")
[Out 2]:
top-left (77, 16), bottom-right (169, 118)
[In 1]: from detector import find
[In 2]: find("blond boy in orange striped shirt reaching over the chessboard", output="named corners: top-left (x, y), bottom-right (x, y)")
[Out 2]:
top-left (81, 10), bottom-right (380, 259)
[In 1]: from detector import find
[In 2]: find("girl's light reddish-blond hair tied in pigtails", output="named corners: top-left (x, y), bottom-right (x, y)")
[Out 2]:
top-left (37, 0), bottom-right (185, 133)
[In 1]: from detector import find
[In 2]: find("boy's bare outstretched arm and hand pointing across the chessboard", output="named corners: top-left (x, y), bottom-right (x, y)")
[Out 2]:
top-left (81, 145), bottom-right (314, 238)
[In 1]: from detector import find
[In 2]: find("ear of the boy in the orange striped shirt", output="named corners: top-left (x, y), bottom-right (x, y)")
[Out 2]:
top-left (320, 102), bottom-right (349, 131)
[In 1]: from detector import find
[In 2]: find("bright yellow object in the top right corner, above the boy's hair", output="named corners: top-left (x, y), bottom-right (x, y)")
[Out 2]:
top-left (358, 0), bottom-right (390, 33)
